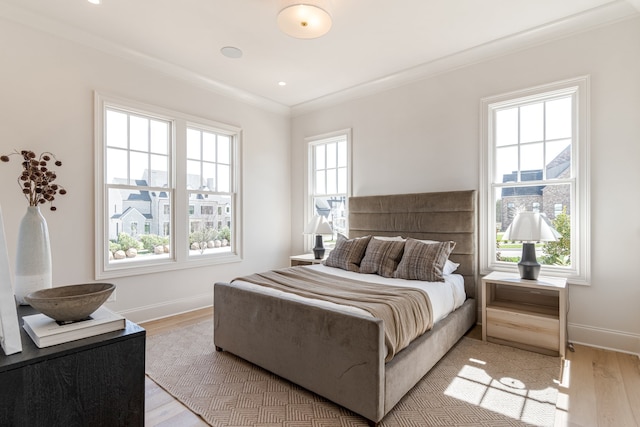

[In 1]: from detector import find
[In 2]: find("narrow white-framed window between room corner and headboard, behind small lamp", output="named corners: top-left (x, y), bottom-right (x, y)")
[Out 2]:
top-left (305, 130), bottom-right (351, 250)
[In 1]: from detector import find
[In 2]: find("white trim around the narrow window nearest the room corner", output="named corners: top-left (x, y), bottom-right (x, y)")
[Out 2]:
top-left (303, 128), bottom-right (353, 252)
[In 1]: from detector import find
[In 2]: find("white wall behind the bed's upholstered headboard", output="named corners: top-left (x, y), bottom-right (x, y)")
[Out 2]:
top-left (291, 18), bottom-right (640, 353)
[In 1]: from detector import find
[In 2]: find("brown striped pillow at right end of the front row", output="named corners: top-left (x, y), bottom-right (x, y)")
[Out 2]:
top-left (395, 239), bottom-right (456, 282)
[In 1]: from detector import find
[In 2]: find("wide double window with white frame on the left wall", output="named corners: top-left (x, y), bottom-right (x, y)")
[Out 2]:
top-left (95, 94), bottom-right (241, 278)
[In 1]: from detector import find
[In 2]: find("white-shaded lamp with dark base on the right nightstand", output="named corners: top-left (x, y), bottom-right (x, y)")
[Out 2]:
top-left (502, 212), bottom-right (562, 280)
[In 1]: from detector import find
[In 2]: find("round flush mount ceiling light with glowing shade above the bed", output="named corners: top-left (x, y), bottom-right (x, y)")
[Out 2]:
top-left (278, 4), bottom-right (331, 39)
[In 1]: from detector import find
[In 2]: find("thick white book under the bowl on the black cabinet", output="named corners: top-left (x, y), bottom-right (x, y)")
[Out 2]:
top-left (22, 307), bottom-right (126, 348)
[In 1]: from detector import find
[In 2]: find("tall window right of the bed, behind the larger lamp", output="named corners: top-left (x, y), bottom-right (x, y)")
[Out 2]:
top-left (480, 77), bottom-right (590, 284)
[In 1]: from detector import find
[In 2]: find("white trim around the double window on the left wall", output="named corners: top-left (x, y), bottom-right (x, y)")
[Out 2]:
top-left (94, 92), bottom-right (244, 280)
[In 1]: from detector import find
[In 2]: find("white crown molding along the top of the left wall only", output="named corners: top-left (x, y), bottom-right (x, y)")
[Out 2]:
top-left (0, 1), bottom-right (291, 116)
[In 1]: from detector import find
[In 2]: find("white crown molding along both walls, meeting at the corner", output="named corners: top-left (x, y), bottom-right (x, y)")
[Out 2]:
top-left (0, 0), bottom-right (640, 116)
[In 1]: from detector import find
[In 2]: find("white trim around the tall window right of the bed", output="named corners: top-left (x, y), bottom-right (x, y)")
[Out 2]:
top-left (479, 76), bottom-right (591, 285)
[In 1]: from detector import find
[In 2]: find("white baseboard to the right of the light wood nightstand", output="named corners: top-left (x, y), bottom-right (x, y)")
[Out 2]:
top-left (568, 323), bottom-right (640, 357)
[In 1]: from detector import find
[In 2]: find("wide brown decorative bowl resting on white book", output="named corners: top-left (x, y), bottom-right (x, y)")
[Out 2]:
top-left (24, 283), bottom-right (116, 322)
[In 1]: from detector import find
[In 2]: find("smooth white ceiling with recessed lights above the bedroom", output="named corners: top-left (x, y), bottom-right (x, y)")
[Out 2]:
top-left (0, 0), bottom-right (640, 110)
